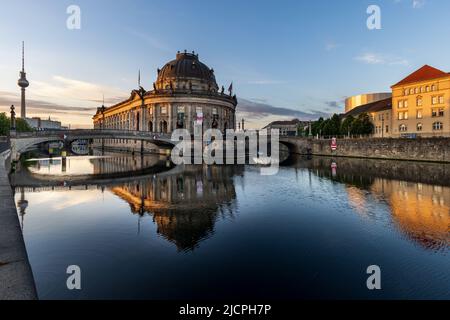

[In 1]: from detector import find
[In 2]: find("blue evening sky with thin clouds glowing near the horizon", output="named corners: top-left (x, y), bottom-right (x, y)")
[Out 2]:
top-left (0, 0), bottom-right (450, 128)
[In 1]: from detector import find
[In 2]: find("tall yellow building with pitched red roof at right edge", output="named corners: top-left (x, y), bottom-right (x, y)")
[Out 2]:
top-left (392, 65), bottom-right (450, 138)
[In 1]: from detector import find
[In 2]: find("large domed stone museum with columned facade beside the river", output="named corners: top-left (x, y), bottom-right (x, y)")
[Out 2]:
top-left (93, 51), bottom-right (237, 149)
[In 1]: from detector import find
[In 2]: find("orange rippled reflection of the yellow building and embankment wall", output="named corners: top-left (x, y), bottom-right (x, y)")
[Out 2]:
top-left (290, 157), bottom-right (450, 250)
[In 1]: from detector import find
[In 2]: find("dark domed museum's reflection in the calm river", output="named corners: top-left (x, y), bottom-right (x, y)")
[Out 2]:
top-left (106, 166), bottom-right (243, 251)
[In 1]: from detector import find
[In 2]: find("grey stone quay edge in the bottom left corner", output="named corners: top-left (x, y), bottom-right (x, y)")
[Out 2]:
top-left (0, 151), bottom-right (37, 300)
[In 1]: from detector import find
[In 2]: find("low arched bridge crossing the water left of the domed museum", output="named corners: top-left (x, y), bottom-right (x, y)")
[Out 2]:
top-left (10, 129), bottom-right (174, 161)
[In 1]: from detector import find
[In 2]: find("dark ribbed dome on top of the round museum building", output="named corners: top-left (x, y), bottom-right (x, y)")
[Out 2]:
top-left (156, 51), bottom-right (218, 91)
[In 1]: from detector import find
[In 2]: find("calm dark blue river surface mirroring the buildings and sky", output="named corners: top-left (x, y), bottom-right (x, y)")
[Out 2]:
top-left (12, 155), bottom-right (450, 299)
